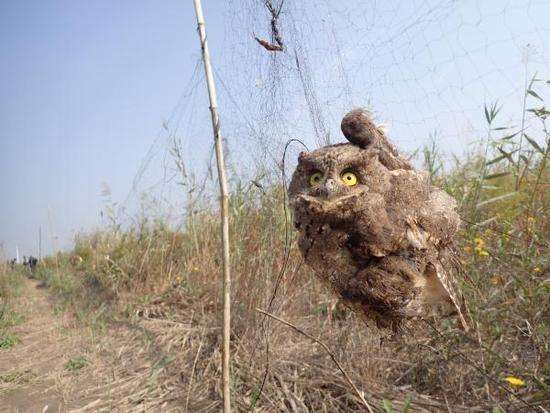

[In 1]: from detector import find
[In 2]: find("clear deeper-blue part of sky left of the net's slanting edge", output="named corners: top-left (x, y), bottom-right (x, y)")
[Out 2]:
top-left (0, 1), bottom-right (215, 255)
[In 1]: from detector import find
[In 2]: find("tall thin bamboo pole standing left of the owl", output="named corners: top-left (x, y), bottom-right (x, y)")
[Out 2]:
top-left (193, 0), bottom-right (231, 413)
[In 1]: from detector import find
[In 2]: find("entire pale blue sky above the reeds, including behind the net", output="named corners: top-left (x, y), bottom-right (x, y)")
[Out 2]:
top-left (0, 0), bottom-right (550, 256)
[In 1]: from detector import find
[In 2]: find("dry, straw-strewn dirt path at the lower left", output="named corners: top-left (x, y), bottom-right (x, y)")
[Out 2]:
top-left (0, 279), bottom-right (177, 413)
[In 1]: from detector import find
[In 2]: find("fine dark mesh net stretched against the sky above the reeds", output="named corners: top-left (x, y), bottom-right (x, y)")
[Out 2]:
top-left (124, 0), bottom-right (550, 216)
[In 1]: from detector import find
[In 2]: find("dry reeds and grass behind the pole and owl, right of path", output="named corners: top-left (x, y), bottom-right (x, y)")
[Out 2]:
top-left (2, 96), bottom-right (550, 412)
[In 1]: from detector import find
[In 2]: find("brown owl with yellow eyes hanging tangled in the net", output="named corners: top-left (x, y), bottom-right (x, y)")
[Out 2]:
top-left (289, 109), bottom-right (468, 331)
